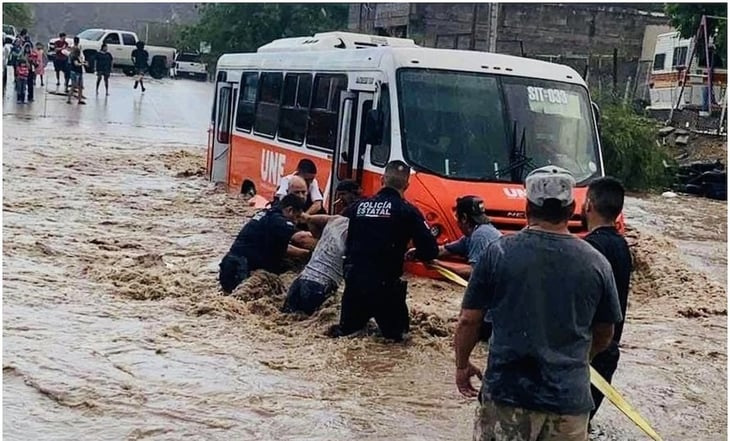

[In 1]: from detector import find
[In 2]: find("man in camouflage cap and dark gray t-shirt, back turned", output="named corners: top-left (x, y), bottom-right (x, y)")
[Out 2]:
top-left (454, 166), bottom-right (622, 441)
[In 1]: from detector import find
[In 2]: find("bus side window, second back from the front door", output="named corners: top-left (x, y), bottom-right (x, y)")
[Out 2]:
top-left (279, 74), bottom-right (312, 145)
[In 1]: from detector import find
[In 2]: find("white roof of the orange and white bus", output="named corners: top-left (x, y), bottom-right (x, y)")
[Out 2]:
top-left (218, 46), bottom-right (585, 86)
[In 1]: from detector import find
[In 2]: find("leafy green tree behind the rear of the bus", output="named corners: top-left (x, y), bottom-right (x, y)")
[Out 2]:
top-left (179, 3), bottom-right (349, 59)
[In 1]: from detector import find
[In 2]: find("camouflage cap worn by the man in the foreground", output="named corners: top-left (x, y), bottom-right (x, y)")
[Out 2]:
top-left (525, 165), bottom-right (575, 207)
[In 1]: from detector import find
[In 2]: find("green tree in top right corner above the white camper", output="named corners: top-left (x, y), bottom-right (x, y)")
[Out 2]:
top-left (664, 3), bottom-right (727, 64)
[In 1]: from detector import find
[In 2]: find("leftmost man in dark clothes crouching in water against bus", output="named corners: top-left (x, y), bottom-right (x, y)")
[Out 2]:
top-left (219, 195), bottom-right (310, 294)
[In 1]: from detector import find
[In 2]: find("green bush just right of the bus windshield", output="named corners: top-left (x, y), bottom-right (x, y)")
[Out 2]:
top-left (594, 97), bottom-right (671, 191)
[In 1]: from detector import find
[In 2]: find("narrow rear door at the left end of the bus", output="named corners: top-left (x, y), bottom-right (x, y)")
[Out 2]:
top-left (209, 82), bottom-right (238, 184)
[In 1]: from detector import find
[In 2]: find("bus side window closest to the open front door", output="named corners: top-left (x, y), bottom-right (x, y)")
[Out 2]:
top-left (307, 74), bottom-right (347, 151)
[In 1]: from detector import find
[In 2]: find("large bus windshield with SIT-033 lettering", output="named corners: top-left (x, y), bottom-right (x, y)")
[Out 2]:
top-left (398, 68), bottom-right (599, 184)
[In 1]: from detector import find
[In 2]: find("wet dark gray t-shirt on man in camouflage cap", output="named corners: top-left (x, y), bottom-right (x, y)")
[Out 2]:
top-left (462, 229), bottom-right (621, 415)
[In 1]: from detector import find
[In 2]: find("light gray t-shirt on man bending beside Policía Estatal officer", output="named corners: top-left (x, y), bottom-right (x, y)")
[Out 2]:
top-left (301, 216), bottom-right (350, 286)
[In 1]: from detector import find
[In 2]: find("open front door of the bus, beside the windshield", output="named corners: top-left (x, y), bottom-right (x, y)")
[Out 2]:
top-left (328, 91), bottom-right (373, 213)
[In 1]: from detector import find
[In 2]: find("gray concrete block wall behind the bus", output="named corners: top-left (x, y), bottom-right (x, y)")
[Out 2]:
top-left (350, 3), bottom-right (668, 95)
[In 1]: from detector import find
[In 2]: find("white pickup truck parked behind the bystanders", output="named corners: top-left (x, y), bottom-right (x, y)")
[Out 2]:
top-left (48, 29), bottom-right (176, 79)
